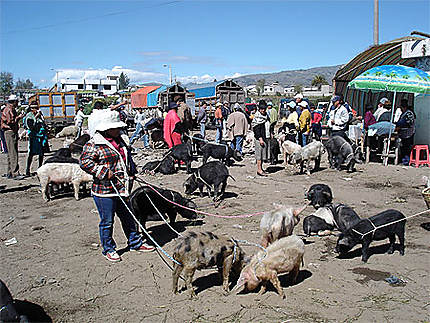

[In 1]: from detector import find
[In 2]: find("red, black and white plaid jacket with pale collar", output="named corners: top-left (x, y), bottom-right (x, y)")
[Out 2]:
top-left (79, 133), bottom-right (137, 197)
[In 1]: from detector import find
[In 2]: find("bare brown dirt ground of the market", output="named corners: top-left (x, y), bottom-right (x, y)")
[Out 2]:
top-left (0, 132), bottom-right (430, 322)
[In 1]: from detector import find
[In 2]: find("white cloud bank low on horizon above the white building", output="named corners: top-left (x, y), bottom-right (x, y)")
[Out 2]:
top-left (55, 66), bottom-right (166, 84)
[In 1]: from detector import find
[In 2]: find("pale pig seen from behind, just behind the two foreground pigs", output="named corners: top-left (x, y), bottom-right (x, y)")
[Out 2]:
top-left (260, 205), bottom-right (306, 248)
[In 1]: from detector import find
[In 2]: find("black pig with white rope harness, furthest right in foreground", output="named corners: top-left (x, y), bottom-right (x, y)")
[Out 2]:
top-left (336, 210), bottom-right (406, 262)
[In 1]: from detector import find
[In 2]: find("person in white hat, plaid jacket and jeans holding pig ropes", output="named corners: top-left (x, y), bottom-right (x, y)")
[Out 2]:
top-left (79, 110), bottom-right (154, 262)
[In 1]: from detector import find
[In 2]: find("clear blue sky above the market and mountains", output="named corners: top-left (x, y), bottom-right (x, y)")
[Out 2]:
top-left (0, 0), bottom-right (430, 87)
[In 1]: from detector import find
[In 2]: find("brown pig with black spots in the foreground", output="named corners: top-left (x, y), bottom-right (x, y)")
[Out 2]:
top-left (172, 232), bottom-right (244, 297)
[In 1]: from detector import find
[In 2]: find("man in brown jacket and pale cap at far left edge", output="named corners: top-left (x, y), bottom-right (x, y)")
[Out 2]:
top-left (1, 94), bottom-right (24, 179)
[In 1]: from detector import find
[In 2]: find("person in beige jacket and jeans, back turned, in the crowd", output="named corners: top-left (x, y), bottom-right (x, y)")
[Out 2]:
top-left (226, 103), bottom-right (248, 154)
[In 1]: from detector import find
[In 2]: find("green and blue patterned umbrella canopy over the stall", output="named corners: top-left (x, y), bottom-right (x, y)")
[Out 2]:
top-left (348, 65), bottom-right (430, 94)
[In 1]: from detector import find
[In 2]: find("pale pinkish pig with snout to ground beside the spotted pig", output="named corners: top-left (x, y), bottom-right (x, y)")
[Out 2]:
top-left (233, 235), bottom-right (305, 298)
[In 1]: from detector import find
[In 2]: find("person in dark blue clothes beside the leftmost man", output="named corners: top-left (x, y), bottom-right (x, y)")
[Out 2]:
top-left (24, 101), bottom-right (48, 176)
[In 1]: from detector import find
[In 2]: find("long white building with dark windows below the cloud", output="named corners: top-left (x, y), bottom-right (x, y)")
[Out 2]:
top-left (59, 75), bottom-right (118, 95)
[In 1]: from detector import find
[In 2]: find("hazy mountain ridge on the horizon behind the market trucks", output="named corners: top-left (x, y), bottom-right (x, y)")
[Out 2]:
top-left (234, 65), bottom-right (342, 87)
